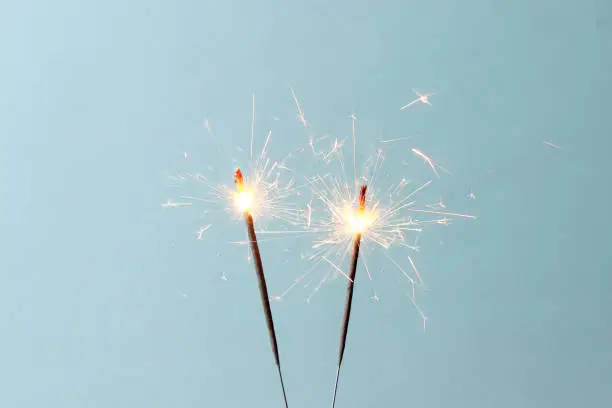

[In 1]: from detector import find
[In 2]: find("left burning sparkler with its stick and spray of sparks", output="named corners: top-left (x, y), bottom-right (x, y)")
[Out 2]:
top-left (163, 95), bottom-right (308, 407)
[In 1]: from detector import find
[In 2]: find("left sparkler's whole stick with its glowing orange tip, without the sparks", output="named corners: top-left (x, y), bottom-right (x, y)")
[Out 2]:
top-left (234, 169), bottom-right (289, 408)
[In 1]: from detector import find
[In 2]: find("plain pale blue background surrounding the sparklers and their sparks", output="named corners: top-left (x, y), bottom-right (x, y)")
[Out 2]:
top-left (0, 0), bottom-right (612, 408)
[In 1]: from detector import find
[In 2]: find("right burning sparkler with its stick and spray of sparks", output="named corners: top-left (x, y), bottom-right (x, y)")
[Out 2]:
top-left (296, 141), bottom-right (476, 408)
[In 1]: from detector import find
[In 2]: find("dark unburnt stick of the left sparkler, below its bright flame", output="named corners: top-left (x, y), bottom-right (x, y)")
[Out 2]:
top-left (244, 212), bottom-right (289, 408)
